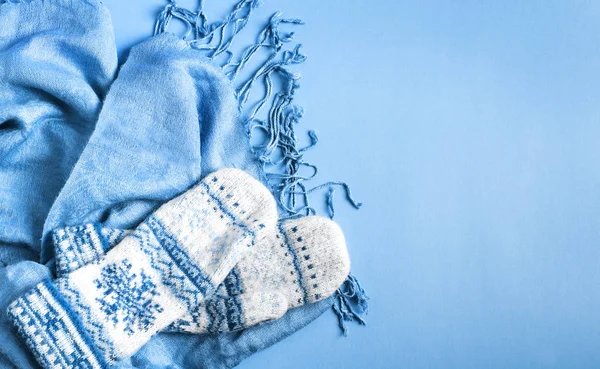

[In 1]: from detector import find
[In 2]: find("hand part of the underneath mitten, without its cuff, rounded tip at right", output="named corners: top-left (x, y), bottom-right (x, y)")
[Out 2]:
top-left (54, 217), bottom-right (349, 333)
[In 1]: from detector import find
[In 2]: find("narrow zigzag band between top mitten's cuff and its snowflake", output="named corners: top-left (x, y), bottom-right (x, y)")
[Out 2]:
top-left (54, 278), bottom-right (117, 364)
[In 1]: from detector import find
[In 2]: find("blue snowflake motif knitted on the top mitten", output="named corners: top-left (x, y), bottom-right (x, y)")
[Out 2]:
top-left (94, 259), bottom-right (163, 335)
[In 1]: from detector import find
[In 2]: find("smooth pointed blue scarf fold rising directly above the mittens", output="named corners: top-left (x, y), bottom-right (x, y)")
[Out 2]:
top-left (41, 33), bottom-right (258, 262)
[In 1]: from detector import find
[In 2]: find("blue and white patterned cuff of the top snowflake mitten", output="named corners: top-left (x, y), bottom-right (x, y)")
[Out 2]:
top-left (8, 281), bottom-right (108, 369)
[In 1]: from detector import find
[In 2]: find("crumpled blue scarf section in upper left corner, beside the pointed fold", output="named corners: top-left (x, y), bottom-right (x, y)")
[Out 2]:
top-left (0, 0), bottom-right (117, 265)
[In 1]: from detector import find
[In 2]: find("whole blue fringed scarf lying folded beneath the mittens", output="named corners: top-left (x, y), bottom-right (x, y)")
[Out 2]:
top-left (0, 0), bottom-right (366, 368)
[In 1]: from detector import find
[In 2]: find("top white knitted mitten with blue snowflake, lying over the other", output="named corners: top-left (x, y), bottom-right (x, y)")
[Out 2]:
top-left (8, 169), bottom-right (277, 368)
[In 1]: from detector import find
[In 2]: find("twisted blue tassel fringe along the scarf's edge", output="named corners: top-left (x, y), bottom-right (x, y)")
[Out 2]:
top-left (154, 0), bottom-right (368, 335)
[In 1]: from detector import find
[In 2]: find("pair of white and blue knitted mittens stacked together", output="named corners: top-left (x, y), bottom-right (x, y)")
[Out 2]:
top-left (8, 169), bottom-right (349, 368)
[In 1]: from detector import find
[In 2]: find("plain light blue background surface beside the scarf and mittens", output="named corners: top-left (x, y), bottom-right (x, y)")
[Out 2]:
top-left (105, 0), bottom-right (600, 369)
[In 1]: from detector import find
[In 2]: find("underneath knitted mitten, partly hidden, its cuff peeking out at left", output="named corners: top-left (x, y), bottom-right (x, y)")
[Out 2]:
top-left (52, 216), bottom-right (350, 333)
